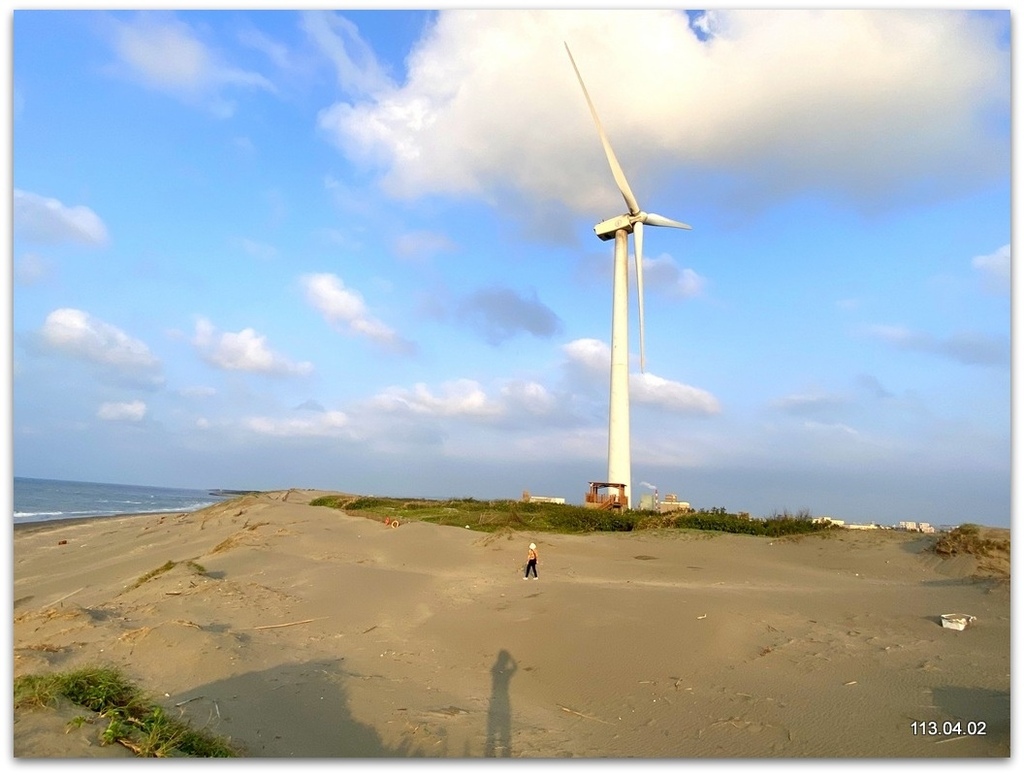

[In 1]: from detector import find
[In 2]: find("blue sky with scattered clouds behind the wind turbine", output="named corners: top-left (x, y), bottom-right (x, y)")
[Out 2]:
top-left (10, 9), bottom-right (1011, 525)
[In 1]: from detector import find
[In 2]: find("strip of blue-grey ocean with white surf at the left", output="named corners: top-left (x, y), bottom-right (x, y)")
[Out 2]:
top-left (13, 476), bottom-right (224, 524)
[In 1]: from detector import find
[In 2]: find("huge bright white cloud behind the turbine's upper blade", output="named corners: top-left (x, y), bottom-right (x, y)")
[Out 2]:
top-left (319, 9), bottom-right (1010, 214)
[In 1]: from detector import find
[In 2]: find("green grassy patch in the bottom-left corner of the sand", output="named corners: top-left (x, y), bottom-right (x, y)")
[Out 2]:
top-left (14, 668), bottom-right (240, 758)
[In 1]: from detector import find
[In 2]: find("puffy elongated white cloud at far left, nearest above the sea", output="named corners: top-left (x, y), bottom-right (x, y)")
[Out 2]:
top-left (39, 307), bottom-right (163, 384)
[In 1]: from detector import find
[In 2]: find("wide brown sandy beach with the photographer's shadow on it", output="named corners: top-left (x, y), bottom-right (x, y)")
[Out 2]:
top-left (13, 489), bottom-right (1011, 759)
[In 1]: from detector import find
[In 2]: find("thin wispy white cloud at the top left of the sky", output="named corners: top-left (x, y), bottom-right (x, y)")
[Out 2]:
top-left (113, 12), bottom-right (275, 118)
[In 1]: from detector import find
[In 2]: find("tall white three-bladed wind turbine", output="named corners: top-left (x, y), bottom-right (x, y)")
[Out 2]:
top-left (565, 43), bottom-right (690, 508)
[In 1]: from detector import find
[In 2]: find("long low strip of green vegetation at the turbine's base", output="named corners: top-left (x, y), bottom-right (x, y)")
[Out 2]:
top-left (310, 496), bottom-right (831, 537)
